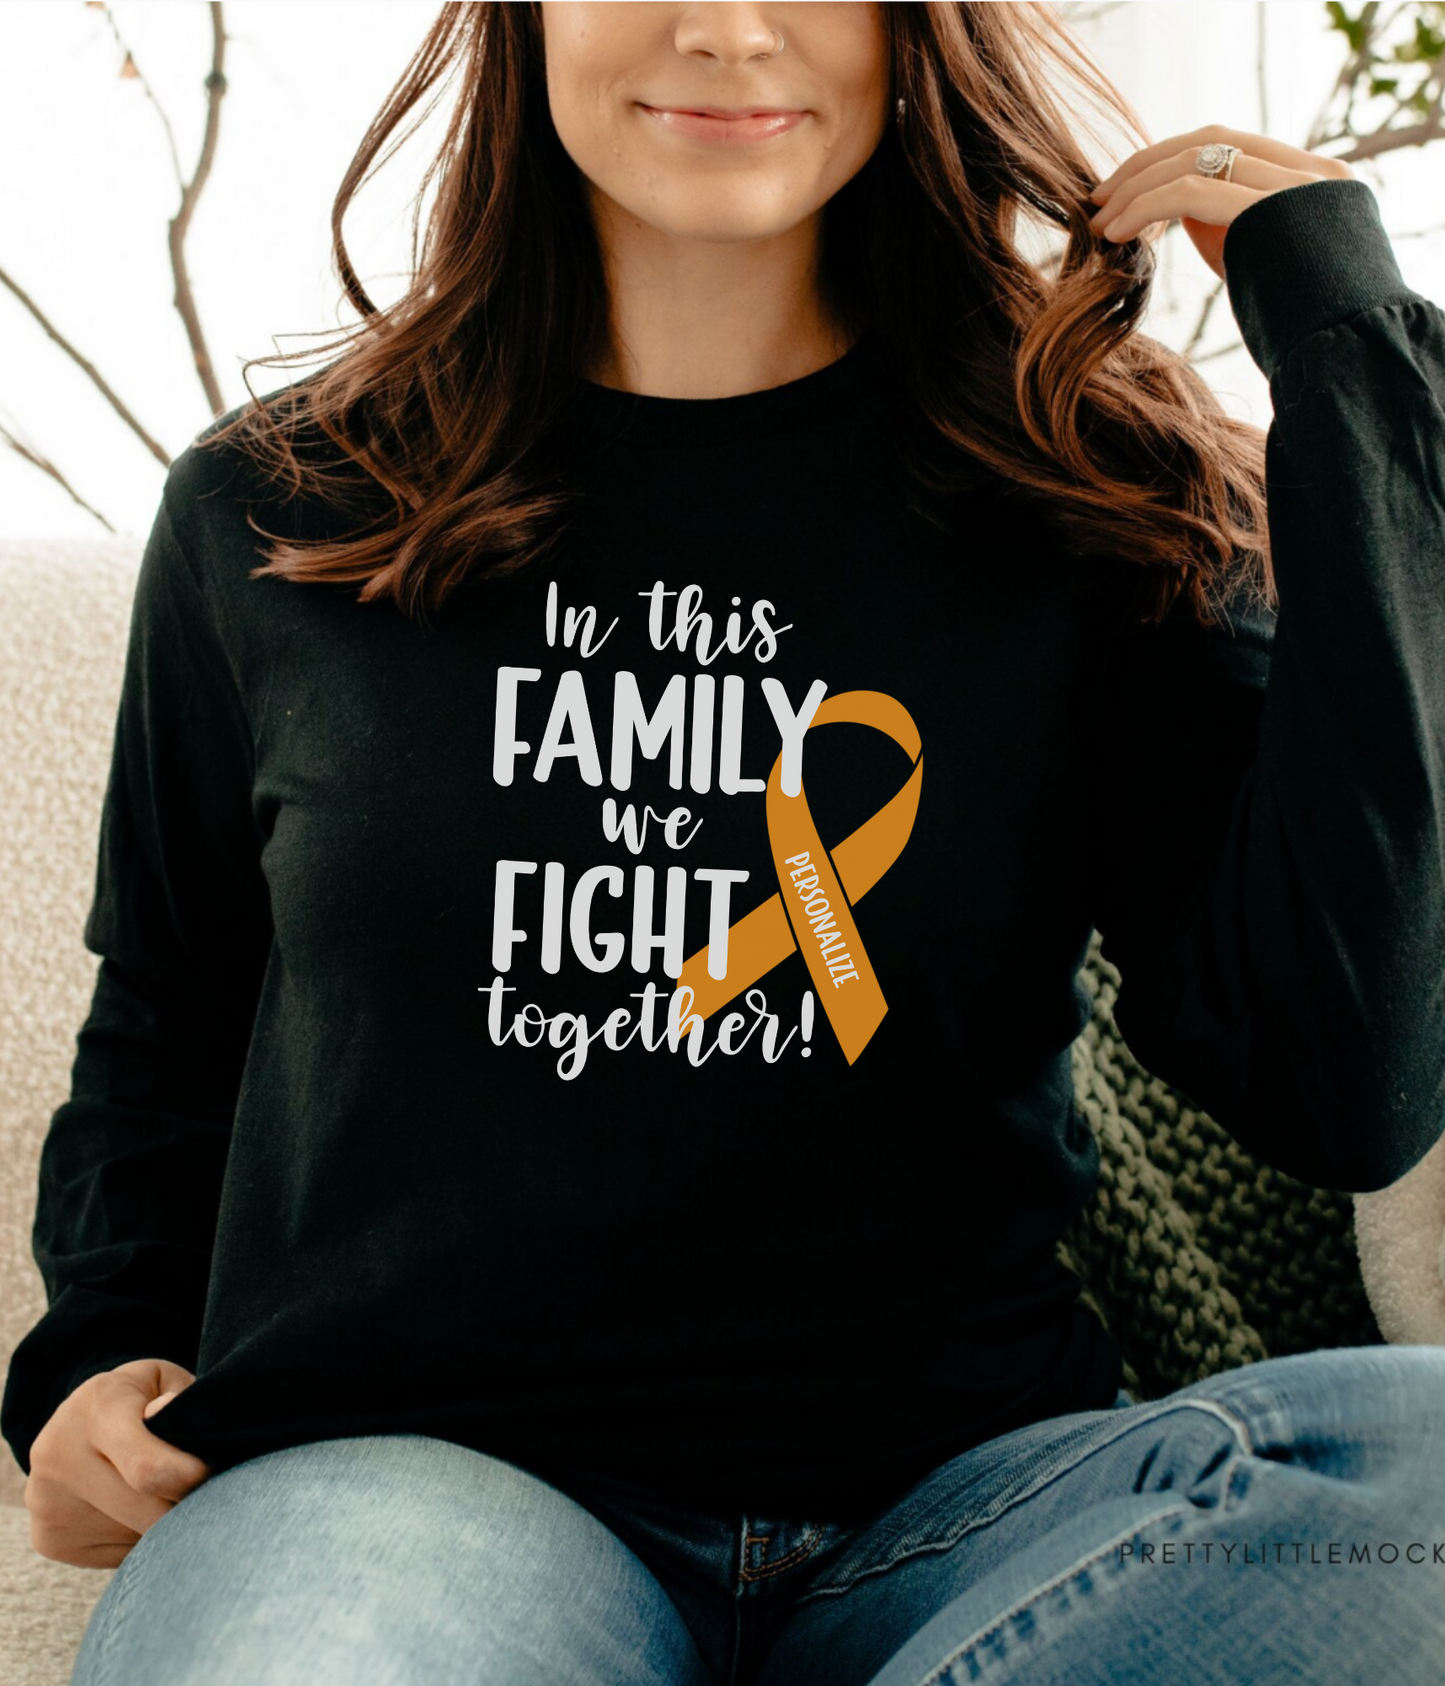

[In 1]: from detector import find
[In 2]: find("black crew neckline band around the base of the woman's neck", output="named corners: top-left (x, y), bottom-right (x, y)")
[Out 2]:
top-left (573, 334), bottom-right (870, 447)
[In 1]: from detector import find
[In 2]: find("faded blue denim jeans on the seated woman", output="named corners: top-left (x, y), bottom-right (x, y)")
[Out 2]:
top-left (73, 1345), bottom-right (1445, 1686)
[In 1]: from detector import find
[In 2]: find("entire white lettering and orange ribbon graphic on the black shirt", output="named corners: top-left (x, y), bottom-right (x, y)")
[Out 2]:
top-left (481, 580), bottom-right (922, 1079)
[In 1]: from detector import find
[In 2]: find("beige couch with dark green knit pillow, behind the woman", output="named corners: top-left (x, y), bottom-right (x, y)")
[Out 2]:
top-left (0, 540), bottom-right (1445, 1686)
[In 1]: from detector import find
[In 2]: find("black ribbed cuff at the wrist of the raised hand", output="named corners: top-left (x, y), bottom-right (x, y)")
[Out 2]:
top-left (1222, 175), bottom-right (1420, 381)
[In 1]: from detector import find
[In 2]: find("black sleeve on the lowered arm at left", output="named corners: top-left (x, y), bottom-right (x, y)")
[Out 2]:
top-left (0, 459), bottom-right (271, 1474)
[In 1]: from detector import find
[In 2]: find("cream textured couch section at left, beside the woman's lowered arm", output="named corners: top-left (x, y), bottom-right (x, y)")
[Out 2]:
top-left (0, 540), bottom-right (142, 1686)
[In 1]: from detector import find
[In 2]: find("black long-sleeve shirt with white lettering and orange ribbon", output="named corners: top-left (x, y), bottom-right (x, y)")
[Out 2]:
top-left (0, 180), bottom-right (1445, 1516)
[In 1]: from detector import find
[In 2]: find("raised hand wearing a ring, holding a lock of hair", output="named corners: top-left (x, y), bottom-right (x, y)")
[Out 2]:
top-left (1089, 123), bottom-right (1354, 280)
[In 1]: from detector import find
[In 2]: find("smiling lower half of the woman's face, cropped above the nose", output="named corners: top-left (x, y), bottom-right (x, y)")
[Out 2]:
top-left (541, 0), bottom-right (889, 239)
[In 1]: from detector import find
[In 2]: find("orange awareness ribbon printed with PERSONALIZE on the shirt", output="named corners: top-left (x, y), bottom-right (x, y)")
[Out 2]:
top-left (676, 691), bottom-right (924, 1066)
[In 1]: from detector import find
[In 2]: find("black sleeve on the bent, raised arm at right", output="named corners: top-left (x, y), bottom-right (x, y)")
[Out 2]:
top-left (1088, 179), bottom-right (1445, 1194)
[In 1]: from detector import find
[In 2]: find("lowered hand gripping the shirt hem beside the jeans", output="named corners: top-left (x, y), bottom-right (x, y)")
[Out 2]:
top-left (25, 1359), bottom-right (211, 1570)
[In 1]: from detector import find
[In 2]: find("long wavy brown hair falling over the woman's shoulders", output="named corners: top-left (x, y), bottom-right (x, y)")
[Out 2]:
top-left (204, 0), bottom-right (1276, 624)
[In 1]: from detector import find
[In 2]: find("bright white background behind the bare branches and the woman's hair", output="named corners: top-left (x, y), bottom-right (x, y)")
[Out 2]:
top-left (0, 0), bottom-right (1445, 534)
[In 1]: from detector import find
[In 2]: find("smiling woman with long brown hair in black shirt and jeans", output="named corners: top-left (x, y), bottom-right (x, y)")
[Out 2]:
top-left (5, 0), bottom-right (1445, 1686)
